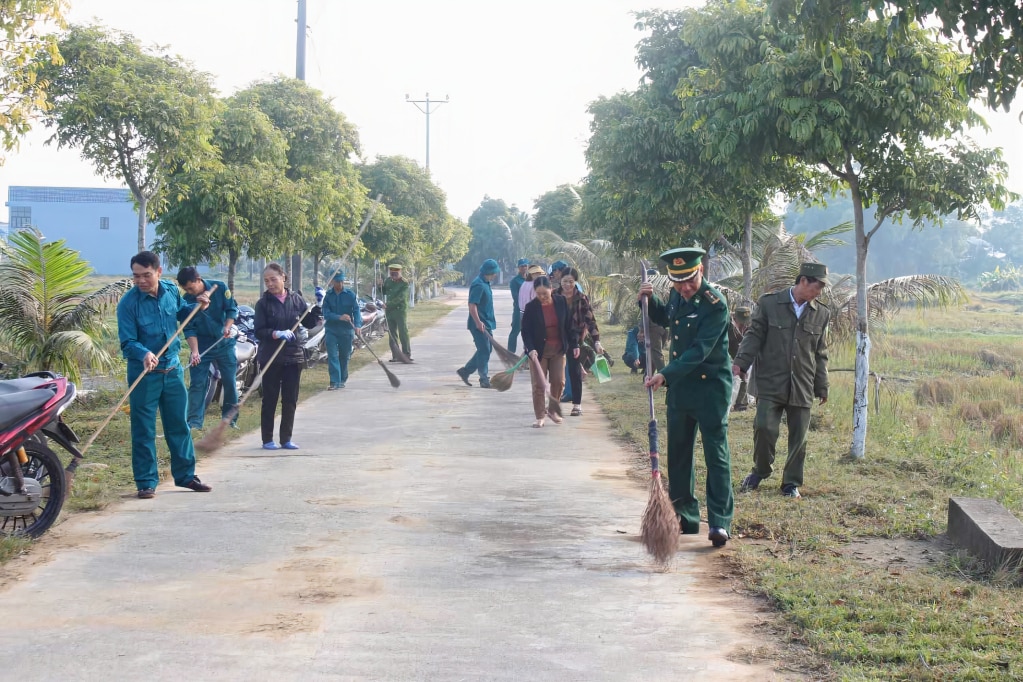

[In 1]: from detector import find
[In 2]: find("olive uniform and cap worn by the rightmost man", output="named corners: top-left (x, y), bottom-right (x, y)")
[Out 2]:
top-left (735, 263), bottom-right (831, 489)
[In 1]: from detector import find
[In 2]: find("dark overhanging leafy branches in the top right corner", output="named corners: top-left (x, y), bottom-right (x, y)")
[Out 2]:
top-left (771, 0), bottom-right (1023, 111)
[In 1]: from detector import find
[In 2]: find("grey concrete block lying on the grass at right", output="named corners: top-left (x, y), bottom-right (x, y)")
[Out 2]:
top-left (948, 497), bottom-right (1023, 566)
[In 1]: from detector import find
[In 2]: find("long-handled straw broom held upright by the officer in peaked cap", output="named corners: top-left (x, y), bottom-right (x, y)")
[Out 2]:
top-left (639, 263), bottom-right (679, 564)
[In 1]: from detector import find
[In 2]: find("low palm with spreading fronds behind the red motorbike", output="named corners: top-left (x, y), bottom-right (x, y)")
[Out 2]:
top-left (0, 228), bottom-right (132, 381)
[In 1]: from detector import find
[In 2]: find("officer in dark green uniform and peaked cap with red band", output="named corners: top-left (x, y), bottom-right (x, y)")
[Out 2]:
top-left (639, 248), bottom-right (733, 547)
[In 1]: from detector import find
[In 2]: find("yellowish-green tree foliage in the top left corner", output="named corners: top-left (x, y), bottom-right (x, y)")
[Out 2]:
top-left (0, 0), bottom-right (68, 160)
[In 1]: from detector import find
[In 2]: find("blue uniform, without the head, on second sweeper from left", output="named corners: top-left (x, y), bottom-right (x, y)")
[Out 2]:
top-left (184, 279), bottom-right (238, 428)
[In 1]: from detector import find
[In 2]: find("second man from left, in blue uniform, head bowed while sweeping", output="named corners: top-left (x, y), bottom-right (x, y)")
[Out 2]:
top-left (178, 266), bottom-right (238, 428)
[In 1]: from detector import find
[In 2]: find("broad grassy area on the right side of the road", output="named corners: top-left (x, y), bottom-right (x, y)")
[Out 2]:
top-left (589, 300), bottom-right (1023, 680)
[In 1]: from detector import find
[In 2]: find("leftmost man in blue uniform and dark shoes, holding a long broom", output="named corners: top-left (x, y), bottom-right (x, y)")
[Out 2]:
top-left (118, 252), bottom-right (212, 499)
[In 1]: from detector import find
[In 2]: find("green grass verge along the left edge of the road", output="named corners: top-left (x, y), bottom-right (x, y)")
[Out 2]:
top-left (58, 300), bottom-right (451, 515)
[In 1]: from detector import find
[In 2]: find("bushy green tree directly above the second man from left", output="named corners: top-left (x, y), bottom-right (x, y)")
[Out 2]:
top-left (157, 97), bottom-right (306, 288)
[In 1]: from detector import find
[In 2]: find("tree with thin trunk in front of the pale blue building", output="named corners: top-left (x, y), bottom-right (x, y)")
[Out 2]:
top-left (43, 26), bottom-right (216, 251)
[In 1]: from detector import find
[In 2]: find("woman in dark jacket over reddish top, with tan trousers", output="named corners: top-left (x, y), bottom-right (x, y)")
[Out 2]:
top-left (522, 276), bottom-right (576, 428)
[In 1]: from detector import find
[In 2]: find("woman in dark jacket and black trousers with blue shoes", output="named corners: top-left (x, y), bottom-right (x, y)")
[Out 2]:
top-left (255, 263), bottom-right (308, 450)
